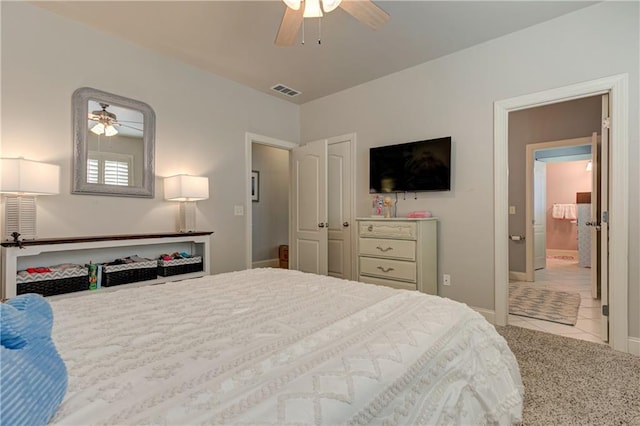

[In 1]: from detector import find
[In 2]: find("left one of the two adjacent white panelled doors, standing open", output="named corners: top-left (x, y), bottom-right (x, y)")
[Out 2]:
top-left (289, 140), bottom-right (328, 275)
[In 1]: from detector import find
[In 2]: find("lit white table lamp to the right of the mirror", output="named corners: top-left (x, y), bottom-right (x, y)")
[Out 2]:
top-left (164, 175), bottom-right (209, 232)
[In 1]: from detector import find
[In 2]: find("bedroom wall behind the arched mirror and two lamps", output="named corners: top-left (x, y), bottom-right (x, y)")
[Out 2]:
top-left (1, 2), bottom-right (299, 273)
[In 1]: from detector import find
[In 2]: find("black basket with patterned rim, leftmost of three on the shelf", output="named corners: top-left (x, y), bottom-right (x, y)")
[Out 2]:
top-left (16, 267), bottom-right (89, 296)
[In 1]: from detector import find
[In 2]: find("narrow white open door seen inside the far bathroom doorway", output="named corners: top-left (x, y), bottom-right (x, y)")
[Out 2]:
top-left (533, 160), bottom-right (547, 269)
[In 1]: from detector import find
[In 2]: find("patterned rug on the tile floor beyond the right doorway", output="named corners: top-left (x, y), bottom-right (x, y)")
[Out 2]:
top-left (509, 282), bottom-right (580, 325)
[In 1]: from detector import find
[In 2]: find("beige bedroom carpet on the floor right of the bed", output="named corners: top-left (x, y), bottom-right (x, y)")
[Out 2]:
top-left (496, 326), bottom-right (640, 426)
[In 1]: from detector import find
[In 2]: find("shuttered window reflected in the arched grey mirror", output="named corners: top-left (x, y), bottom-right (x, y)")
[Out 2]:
top-left (87, 151), bottom-right (134, 186)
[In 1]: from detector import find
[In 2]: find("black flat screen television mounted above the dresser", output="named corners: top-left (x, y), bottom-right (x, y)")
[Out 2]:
top-left (369, 136), bottom-right (451, 193)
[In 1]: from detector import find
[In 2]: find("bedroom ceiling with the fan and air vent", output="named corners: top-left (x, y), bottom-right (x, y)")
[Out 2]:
top-left (33, 0), bottom-right (597, 104)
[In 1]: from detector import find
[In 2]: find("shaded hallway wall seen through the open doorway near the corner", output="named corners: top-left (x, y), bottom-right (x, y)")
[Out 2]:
top-left (251, 144), bottom-right (289, 262)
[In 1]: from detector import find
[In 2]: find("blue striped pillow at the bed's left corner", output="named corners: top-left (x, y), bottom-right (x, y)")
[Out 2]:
top-left (0, 294), bottom-right (67, 425)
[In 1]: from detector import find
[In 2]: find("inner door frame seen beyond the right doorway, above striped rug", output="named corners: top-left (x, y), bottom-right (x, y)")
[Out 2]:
top-left (524, 136), bottom-right (591, 282)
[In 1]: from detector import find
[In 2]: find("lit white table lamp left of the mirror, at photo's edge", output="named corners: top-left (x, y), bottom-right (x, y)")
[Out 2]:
top-left (0, 158), bottom-right (60, 240)
